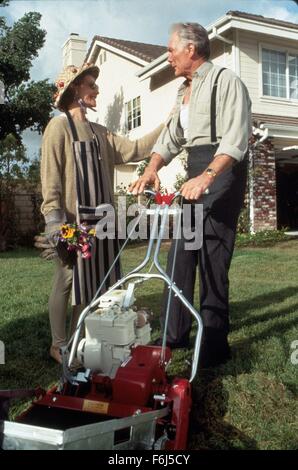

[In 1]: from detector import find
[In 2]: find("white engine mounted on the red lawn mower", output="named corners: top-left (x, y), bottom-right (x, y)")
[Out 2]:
top-left (77, 286), bottom-right (151, 378)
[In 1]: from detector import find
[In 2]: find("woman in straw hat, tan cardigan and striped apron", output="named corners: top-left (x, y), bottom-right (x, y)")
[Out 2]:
top-left (41, 64), bottom-right (162, 363)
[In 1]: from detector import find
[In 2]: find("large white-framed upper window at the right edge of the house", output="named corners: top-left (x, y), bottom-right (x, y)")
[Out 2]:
top-left (262, 49), bottom-right (298, 99)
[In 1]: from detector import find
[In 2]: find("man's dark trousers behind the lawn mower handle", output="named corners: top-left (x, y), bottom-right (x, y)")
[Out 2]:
top-left (161, 145), bottom-right (247, 364)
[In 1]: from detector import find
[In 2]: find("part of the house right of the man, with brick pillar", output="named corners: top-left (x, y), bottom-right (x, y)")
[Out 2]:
top-left (207, 11), bottom-right (298, 231)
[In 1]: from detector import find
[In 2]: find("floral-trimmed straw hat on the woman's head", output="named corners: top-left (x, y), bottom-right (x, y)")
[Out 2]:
top-left (54, 62), bottom-right (99, 108)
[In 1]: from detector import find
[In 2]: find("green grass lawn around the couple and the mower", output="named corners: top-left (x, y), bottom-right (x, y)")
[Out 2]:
top-left (0, 240), bottom-right (298, 449)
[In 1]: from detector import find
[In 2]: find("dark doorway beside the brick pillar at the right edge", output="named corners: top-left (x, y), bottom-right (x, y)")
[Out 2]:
top-left (276, 162), bottom-right (298, 230)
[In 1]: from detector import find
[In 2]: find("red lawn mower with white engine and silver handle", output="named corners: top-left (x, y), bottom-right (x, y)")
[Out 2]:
top-left (0, 190), bottom-right (203, 450)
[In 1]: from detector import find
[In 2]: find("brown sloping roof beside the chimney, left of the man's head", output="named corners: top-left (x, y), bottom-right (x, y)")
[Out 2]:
top-left (87, 36), bottom-right (167, 62)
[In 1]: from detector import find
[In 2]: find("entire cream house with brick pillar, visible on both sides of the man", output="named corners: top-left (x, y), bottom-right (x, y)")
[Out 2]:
top-left (65, 11), bottom-right (298, 231)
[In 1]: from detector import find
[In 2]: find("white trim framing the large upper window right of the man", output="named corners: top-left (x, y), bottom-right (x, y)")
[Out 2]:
top-left (259, 42), bottom-right (298, 106)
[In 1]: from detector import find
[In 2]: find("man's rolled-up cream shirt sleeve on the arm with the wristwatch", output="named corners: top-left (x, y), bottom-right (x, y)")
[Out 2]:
top-left (215, 74), bottom-right (252, 161)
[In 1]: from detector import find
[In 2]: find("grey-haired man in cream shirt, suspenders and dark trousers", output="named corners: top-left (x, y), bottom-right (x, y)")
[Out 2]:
top-left (130, 23), bottom-right (251, 367)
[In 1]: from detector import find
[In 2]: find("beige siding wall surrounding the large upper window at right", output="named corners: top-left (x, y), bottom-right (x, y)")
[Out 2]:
top-left (239, 32), bottom-right (298, 117)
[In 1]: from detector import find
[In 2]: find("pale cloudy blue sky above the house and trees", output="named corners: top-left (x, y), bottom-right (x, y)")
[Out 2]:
top-left (0, 0), bottom-right (298, 153)
